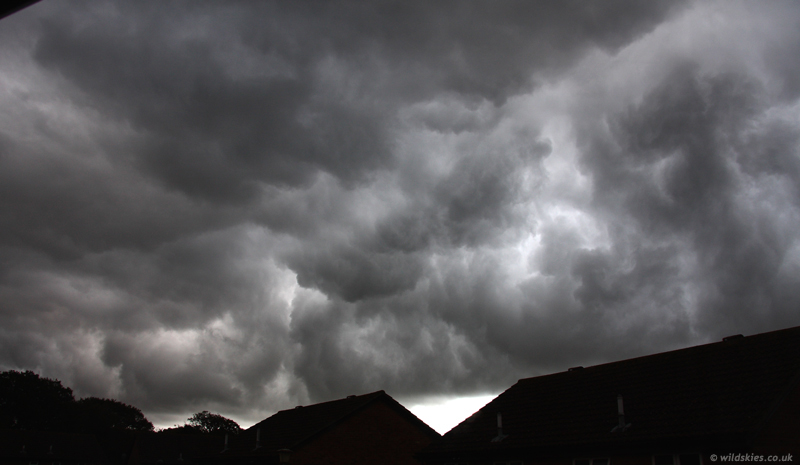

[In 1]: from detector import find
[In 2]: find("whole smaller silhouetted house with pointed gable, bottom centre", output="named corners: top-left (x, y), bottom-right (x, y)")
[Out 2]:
top-left (200, 391), bottom-right (440, 465)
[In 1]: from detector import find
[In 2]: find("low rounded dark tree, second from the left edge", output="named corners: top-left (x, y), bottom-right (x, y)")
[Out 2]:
top-left (75, 397), bottom-right (153, 432)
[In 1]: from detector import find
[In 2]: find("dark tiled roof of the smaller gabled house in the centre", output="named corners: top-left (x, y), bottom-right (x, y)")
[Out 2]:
top-left (219, 391), bottom-right (439, 456)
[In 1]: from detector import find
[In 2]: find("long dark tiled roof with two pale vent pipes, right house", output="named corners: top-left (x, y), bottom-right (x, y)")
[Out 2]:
top-left (425, 327), bottom-right (800, 456)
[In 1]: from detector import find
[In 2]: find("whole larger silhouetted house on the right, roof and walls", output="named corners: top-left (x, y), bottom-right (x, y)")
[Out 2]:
top-left (418, 327), bottom-right (800, 465)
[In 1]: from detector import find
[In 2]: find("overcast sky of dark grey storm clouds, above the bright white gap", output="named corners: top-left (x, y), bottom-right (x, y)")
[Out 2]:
top-left (0, 0), bottom-right (800, 432)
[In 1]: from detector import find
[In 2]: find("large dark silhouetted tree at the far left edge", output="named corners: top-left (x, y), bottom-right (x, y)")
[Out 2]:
top-left (0, 370), bottom-right (75, 431)
